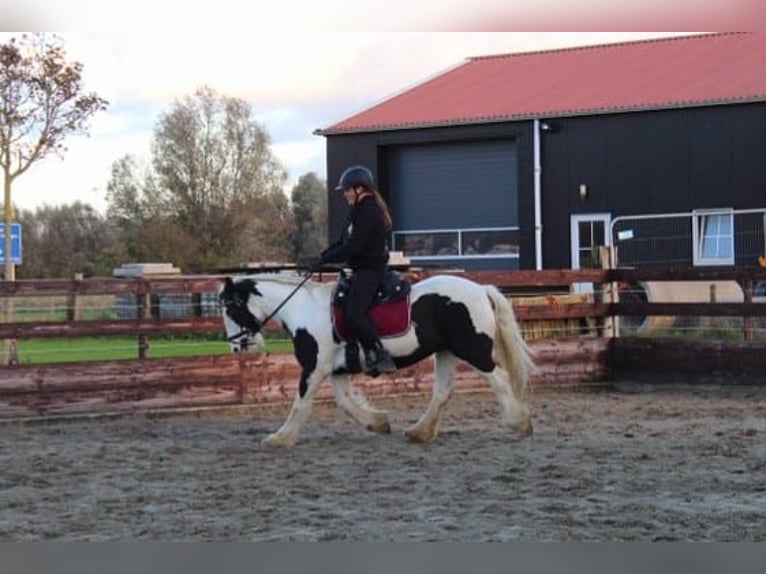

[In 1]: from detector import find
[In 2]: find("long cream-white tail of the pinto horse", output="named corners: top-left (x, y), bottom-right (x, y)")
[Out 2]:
top-left (485, 285), bottom-right (534, 397)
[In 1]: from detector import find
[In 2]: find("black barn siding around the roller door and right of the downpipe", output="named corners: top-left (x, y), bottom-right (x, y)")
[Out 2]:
top-left (327, 102), bottom-right (766, 269)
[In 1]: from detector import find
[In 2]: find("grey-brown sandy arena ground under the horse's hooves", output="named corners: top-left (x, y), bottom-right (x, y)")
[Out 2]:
top-left (0, 385), bottom-right (766, 541)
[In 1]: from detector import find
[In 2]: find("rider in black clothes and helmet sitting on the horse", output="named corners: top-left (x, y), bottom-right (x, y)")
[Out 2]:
top-left (319, 165), bottom-right (396, 377)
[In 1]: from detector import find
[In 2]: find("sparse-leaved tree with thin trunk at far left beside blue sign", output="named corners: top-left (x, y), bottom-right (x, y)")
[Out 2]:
top-left (0, 34), bottom-right (108, 280)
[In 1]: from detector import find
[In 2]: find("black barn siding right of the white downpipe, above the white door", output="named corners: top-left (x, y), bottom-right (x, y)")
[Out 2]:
top-left (542, 103), bottom-right (766, 268)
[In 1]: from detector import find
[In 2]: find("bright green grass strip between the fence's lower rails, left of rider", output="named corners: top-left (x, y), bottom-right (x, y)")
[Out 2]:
top-left (16, 337), bottom-right (293, 365)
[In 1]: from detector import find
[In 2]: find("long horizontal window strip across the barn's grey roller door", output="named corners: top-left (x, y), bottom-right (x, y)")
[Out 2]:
top-left (393, 227), bottom-right (519, 260)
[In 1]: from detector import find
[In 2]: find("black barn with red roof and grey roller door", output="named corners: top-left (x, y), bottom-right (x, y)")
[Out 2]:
top-left (316, 33), bottom-right (766, 270)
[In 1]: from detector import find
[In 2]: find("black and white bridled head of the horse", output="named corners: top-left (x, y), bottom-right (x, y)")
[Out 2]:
top-left (218, 277), bottom-right (265, 353)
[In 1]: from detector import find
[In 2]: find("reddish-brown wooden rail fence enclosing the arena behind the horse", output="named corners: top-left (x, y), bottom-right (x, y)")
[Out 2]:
top-left (0, 269), bottom-right (766, 419)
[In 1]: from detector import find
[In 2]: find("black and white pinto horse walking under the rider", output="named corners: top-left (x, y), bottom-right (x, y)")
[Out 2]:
top-left (218, 273), bottom-right (534, 447)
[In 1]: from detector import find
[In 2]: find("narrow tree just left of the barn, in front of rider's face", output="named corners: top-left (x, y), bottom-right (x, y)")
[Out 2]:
top-left (290, 172), bottom-right (327, 261)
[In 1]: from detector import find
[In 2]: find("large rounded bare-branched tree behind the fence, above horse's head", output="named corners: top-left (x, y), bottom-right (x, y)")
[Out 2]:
top-left (144, 87), bottom-right (292, 270)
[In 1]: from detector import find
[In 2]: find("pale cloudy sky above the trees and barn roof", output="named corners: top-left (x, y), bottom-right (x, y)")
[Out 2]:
top-left (0, 0), bottom-right (749, 216)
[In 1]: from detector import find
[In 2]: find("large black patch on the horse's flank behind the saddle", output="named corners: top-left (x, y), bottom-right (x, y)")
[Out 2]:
top-left (394, 295), bottom-right (495, 373)
